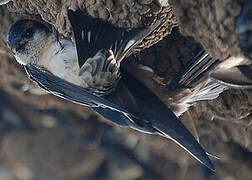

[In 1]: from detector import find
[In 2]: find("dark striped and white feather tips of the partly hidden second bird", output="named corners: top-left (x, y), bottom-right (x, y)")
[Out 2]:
top-left (167, 50), bottom-right (227, 103)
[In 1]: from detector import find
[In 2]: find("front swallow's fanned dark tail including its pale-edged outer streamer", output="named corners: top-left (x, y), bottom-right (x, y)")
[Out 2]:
top-left (68, 10), bottom-right (165, 67)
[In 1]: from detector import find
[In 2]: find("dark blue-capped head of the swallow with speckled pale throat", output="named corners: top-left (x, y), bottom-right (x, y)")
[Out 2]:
top-left (7, 20), bottom-right (49, 65)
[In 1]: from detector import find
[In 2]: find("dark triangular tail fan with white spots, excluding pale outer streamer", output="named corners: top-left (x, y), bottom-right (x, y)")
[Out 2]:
top-left (68, 10), bottom-right (126, 67)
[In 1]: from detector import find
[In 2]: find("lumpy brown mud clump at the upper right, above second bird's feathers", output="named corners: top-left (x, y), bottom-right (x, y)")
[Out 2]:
top-left (169, 0), bottom-right (245, 60)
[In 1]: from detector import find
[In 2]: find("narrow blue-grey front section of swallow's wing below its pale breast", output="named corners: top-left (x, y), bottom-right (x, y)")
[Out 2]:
top-left (25, 64), bottom-right (137, 118)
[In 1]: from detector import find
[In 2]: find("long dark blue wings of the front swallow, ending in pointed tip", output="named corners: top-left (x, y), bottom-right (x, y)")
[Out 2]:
top-left (25, 64), bottom-right (214, 170)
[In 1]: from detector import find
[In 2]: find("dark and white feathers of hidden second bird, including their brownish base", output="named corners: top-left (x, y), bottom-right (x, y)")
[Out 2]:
top-left (166, 50), bottom-right (228, 115)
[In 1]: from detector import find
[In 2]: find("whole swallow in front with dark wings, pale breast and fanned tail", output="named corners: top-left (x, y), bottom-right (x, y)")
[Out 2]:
top-left (7, 10), bottom-right (214, 170)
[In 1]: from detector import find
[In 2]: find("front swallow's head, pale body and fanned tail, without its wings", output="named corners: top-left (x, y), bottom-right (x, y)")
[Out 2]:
top-left (7, 11), bottom-right (164, 96)
